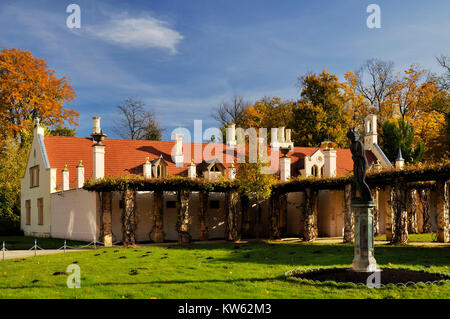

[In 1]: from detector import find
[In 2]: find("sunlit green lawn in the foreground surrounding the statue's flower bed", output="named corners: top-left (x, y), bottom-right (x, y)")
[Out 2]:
top-left (0, 243), bottom-right (450, 299)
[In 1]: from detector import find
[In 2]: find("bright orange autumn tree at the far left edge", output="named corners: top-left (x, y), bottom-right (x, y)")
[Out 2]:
top-left (0, 47), bottom-right (79, 138)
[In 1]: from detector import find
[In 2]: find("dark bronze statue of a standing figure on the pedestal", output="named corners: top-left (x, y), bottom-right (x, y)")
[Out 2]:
top-left (347, 129), bottom-right (373, 202)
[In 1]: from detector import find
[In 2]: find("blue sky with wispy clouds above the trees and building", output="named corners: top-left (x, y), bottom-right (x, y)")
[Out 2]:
top-left (0, 0), bottom-right (450, 139)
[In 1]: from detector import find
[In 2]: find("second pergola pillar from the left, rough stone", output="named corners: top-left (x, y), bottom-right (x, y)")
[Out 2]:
top-left (122, 189), bottom-right (136, 247)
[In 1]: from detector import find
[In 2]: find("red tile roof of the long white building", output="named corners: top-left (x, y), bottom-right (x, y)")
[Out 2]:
top-left (44, 136), bottom-right (376, 189)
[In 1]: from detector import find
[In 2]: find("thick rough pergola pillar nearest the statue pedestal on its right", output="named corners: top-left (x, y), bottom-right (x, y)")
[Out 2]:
top-left (391, 181), bottom-right (408, 245)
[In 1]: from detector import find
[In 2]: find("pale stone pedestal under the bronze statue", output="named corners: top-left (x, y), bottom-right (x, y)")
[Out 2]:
top-left (351, 201), bottom-right (379, 272)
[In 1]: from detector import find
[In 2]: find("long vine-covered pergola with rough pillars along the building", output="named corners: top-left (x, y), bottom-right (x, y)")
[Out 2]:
top-left (84, 163), bottom-right (450, 246)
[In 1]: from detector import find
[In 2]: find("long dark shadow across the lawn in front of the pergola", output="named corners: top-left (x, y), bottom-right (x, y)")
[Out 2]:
top-left (163, 243), bottom-right (450, 268)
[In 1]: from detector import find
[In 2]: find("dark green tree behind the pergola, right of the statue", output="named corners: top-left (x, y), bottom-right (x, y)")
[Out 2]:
top-left (381, 118), bottom-right (425, 163)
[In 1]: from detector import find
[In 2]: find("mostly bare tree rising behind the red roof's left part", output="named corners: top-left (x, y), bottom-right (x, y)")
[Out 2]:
top-left (113, 98), bottom-right (163, 141)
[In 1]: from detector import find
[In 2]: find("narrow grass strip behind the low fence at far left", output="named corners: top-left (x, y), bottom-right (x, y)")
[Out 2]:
top-left (0, 236), bottom-right (88, 250)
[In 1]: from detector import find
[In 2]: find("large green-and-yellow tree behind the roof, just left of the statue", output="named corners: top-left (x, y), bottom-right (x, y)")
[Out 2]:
top-left (291, 70), bottom-right (350, 147)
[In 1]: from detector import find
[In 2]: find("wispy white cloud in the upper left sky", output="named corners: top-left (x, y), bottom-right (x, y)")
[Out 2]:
top-left (88, 16), bottom-right (183, 54)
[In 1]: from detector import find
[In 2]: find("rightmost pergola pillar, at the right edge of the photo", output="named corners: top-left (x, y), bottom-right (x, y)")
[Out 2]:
top-left (436, 180), bottom-right (450, 243)
